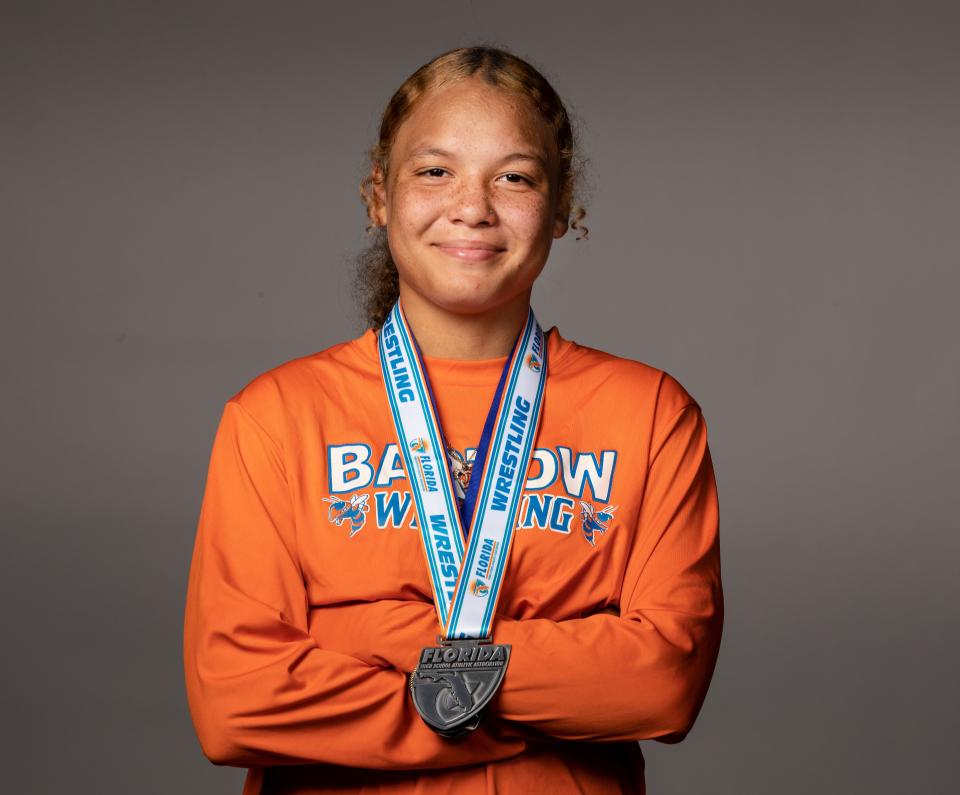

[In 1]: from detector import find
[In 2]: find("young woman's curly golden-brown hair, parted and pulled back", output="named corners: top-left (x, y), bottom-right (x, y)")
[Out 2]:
top-left (354, 46), bottom-right (589, 329)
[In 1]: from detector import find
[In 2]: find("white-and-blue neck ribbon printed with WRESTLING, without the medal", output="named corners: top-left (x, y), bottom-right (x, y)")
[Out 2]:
top-left (379, 302), bottom-right (547, 639)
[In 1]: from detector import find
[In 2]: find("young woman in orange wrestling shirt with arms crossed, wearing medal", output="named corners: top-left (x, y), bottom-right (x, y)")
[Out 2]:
top-left (184, 47), bottom-right (723, 795)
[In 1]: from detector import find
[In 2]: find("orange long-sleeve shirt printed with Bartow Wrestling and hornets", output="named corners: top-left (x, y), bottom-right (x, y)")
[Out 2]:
top-left (184, 328), bottom-right (723, 795)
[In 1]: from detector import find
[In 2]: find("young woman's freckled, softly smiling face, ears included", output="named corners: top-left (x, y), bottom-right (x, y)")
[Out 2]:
top-left (375, 77), bottom-right (568, 314)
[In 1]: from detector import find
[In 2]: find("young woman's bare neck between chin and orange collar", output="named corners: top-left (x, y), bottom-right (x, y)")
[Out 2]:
top-left (400, 284), bottom-right (530, 359)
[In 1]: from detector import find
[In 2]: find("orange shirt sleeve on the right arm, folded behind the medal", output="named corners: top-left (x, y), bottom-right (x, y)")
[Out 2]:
top-left (304, 403), bottom-right (723, 742)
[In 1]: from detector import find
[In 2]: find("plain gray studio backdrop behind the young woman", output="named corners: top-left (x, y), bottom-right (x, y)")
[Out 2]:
top-left (0, 0), bottom-right (960, 795)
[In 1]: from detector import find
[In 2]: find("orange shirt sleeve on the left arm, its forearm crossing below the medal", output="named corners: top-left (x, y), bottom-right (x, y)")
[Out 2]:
top-left (183, 401), bottom-right (527, 769)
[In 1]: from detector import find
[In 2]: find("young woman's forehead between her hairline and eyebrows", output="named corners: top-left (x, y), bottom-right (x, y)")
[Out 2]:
top-left (393, 77), bottom-right (556, 160)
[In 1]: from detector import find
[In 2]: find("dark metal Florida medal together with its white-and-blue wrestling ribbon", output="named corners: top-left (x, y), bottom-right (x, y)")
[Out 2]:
top-left (379, 302), bottom-right (547, 736)
